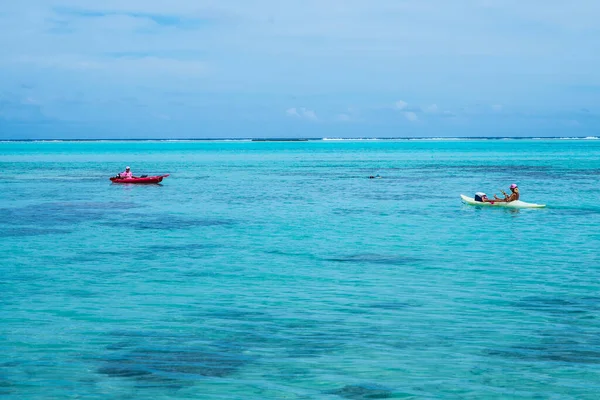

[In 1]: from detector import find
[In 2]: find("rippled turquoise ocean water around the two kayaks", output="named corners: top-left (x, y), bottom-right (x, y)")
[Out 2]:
top-left (0, 140), bottom-right (600, 399)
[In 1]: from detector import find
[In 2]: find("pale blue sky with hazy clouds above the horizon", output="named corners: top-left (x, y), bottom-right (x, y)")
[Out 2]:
top-left (0, 0), bottom-right (600, 139)
